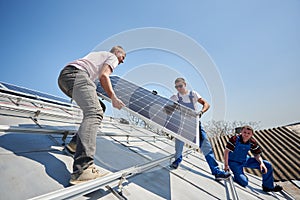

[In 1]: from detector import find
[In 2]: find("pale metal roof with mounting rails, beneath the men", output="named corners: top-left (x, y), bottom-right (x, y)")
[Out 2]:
top-left (0, 83), bottom-right (293, 200)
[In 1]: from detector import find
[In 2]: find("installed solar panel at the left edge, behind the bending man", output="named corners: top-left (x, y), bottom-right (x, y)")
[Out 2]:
top-left (0, 82), bottom-right (70, 104)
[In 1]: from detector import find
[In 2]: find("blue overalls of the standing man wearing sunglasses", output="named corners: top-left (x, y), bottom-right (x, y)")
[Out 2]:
top-left (175, 91), bottom-right (224, 175)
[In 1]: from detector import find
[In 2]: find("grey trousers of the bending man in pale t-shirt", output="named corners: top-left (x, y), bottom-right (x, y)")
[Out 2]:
top-left (58, 65), bottom-right (103, 173)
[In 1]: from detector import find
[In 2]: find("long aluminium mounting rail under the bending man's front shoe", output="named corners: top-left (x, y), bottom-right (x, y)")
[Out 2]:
top-left (31, 154), bottom-right (174, 200)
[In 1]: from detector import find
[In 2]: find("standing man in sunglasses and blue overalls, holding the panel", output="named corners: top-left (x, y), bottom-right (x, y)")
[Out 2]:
top-left (170, 78), bottom-right (230, 181)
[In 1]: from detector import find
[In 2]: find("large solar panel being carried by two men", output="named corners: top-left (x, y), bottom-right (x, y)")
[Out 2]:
top-left (97, 76), bottom-right (199, 148)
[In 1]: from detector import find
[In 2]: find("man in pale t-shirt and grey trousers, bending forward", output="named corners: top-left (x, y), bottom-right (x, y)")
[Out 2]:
top-left (58, 46), bottom-right (126, 184)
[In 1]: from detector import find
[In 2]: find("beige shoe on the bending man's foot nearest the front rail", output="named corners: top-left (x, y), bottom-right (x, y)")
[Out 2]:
top-left (70, 164), bottom-right (109, 185)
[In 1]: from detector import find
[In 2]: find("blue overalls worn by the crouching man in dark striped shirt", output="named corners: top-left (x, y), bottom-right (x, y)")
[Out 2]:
top-left (228, 136), bottom-right (274, 188)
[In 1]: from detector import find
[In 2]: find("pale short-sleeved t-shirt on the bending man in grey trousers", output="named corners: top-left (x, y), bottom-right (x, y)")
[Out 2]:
top-left (68, 51), bottom-right (119, 81)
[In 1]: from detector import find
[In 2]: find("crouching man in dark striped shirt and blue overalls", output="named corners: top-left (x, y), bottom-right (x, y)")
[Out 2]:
top-left (224, 126), bottom-right (282, 192)
